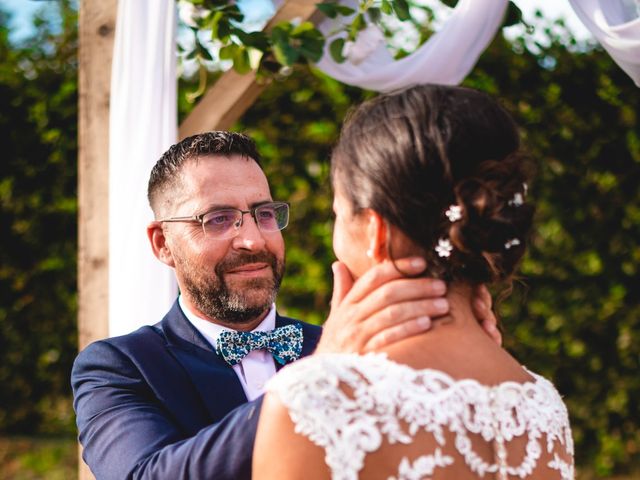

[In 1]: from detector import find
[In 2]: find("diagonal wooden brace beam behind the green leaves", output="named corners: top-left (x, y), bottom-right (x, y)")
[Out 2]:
top-left (179, 0), bottom-right (318, 139)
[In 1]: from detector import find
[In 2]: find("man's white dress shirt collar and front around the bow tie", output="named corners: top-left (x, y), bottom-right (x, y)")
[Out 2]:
top-left (178, 295), bottom-right (276, 401)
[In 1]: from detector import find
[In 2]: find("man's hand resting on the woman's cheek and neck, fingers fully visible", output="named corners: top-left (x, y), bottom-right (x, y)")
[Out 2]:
top-left (316, 258), bottom-right (449, 353)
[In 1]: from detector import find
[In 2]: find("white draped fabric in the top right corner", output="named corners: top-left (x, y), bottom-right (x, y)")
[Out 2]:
top-left (569, 0), bottom-right (640, 87)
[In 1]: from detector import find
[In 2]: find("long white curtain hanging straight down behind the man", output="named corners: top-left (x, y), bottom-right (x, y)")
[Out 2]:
top-left (109, 0), bottom-right (178, 335)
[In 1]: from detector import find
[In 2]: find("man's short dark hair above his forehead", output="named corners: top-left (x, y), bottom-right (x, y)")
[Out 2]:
top-left (147, 131), bottom-right (260, 214)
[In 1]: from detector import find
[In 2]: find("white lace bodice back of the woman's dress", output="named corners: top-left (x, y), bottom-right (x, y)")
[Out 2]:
top-left (267, 354), bottom-right (574, 480)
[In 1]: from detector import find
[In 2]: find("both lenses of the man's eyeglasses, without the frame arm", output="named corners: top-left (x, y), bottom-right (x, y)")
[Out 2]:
top-left (202, 203), bottom-right (289, 237)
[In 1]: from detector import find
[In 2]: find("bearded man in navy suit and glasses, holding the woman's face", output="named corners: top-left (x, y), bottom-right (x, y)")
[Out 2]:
top-left (71, 132), bottom-right (495, 480)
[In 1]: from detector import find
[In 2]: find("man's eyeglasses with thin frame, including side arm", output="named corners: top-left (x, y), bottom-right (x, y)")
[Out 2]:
top-left (158, 202), bottom-right (289, 239)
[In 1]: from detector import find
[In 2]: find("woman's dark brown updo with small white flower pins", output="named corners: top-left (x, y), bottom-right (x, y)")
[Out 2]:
top-left (331, 85), bottom-right (534, 284)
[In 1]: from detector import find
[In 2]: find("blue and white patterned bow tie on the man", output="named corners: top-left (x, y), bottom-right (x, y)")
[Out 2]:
top-left (216, 325), bottom-right (302, 365)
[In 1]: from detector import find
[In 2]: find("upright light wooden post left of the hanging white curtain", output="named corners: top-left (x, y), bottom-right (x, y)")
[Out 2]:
top-left (78, 0), bottom-right (118, 480)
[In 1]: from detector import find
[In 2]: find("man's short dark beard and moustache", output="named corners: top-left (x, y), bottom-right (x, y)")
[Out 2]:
top-left (180, 251), bottom-right (285, 325)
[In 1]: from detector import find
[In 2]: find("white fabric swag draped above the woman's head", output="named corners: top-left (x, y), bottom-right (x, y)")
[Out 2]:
top-left (317, 0), bottom-right (508, 92)
